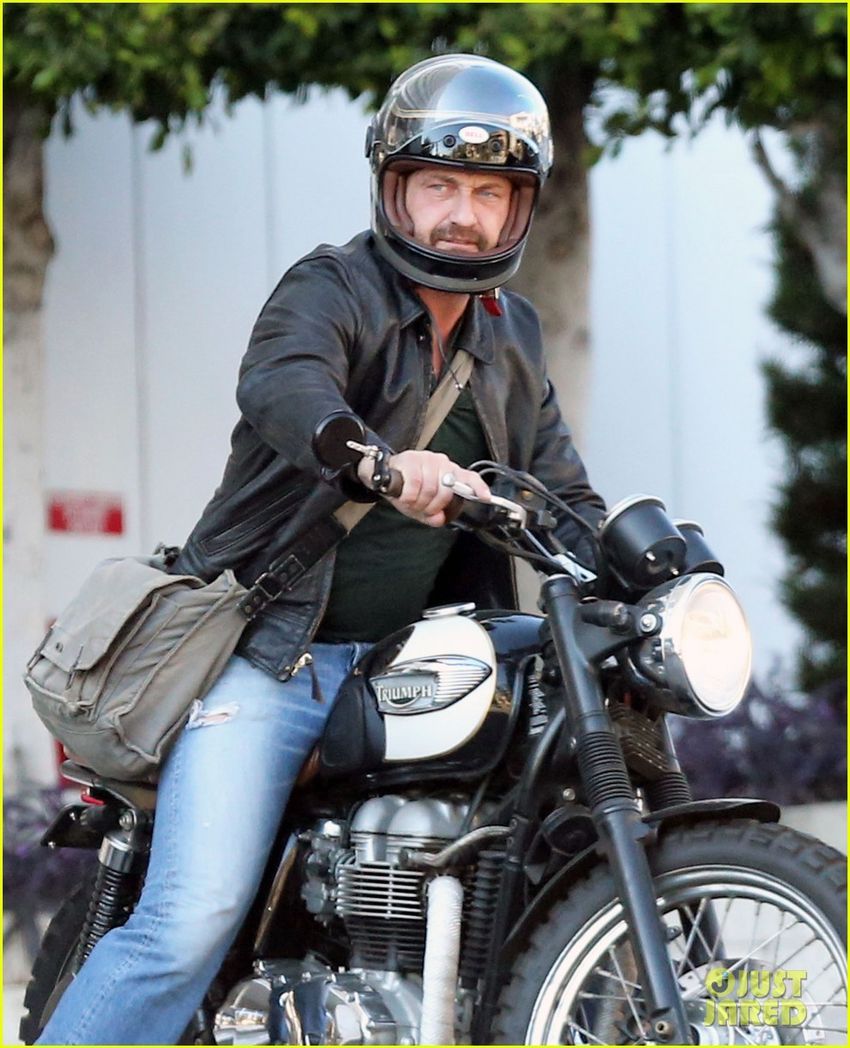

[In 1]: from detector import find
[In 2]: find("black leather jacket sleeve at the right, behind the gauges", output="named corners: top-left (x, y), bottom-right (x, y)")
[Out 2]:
top-left (531, 378), bottom-right (605, 566)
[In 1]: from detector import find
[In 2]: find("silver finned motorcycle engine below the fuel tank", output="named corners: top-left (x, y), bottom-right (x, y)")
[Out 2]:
top-left (215, 794), bottom-right (481, 1045)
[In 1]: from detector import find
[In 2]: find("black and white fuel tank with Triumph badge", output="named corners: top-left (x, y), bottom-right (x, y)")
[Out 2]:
top-left (320, 605), bottom-right (542, 785)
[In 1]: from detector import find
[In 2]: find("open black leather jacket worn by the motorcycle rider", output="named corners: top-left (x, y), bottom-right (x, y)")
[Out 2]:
top-left (172, 233), bottom-right (604, 679)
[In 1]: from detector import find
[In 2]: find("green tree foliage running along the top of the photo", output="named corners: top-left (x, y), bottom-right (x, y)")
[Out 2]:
top-left (3, 3), bottom-right (846, 147)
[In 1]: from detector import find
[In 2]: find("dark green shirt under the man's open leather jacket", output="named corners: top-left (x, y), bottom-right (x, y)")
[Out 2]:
top-left (317, 386), bottom-right (488, 642)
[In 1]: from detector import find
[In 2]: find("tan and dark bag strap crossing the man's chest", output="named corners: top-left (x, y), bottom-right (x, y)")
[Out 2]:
top-left (238, 349), bottom-right (474, 620)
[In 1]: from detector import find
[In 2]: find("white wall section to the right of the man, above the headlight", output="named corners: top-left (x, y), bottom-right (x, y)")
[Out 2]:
top-left (587, 118), bottom-right (800, 683)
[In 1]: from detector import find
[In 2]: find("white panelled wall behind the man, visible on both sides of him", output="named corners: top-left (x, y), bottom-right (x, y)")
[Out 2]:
top-left (6, 92), bottom-right (795, 779)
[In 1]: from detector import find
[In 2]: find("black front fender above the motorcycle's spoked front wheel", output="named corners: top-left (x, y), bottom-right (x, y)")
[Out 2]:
top-left (501, 798), bottom-right (781, 963)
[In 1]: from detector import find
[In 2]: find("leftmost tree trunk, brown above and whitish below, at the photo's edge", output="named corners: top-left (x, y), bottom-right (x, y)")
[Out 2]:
top-left (3, 92), bottom-right (55, 781)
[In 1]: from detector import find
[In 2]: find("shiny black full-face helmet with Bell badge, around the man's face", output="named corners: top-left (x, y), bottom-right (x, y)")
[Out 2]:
top-left (366, 54), bottom-right (552, 293)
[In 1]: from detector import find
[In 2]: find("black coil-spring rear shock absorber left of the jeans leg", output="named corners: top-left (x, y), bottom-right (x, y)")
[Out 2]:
top-left (74, 809), bottom-right (150, 970)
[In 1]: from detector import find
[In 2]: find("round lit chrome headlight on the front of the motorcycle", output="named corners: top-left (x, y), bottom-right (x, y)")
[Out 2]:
top-left (632, 574), bottom-right (753, 717)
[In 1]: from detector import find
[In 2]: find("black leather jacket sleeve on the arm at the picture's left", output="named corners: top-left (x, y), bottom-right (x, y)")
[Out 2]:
top-left (236, 257), bottom-right (389, 479)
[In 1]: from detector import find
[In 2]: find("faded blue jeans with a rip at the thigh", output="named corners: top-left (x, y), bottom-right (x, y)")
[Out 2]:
top-left (38, 643), bottom-right (371, 1045)
